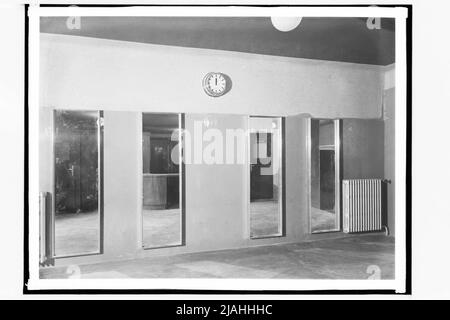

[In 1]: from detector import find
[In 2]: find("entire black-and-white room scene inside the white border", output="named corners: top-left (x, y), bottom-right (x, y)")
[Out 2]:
top-left (39, 16), bottom-right (395, 279)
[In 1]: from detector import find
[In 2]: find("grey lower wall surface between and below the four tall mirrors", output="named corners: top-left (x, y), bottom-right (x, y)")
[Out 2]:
top-left (47, 111), bottom-right (309, 265)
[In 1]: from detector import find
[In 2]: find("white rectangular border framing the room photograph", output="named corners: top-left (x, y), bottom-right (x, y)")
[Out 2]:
top-left (25, 4), bottom-right (408, 294)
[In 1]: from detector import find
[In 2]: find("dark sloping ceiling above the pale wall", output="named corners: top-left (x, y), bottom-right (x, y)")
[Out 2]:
top-left (41, 17), bottom-right (395, 65)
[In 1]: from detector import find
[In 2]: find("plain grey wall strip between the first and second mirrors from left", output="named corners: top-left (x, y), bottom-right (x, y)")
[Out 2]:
top-left (103, 111), bottom-right (142, 258)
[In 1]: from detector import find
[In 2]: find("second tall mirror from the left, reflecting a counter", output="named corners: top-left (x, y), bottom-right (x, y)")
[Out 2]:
top-left (142, 113), bottom-right (182, 248)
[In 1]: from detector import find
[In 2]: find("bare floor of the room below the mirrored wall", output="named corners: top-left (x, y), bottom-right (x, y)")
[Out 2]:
top-left (40, 234), bottom-right (394, 279)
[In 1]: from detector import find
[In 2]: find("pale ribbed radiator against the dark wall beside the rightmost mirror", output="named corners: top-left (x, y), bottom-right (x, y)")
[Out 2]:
top-left (342, 179), bottom-right (384, 233)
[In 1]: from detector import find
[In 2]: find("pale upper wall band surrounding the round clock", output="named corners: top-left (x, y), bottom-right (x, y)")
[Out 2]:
top-left (40, 34), bottom-right (384, 118)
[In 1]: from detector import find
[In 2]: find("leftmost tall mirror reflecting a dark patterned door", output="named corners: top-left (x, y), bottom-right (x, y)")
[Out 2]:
top-left (54, 110), bottom-right (100, 256)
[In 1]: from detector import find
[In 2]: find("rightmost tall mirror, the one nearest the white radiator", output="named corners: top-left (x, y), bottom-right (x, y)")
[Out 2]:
top-left (311, 119), bottom-right (339, 232)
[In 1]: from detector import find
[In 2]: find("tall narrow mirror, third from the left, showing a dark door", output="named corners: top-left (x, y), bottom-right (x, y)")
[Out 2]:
top-left (249, 117), bottom-right (283, 238)
